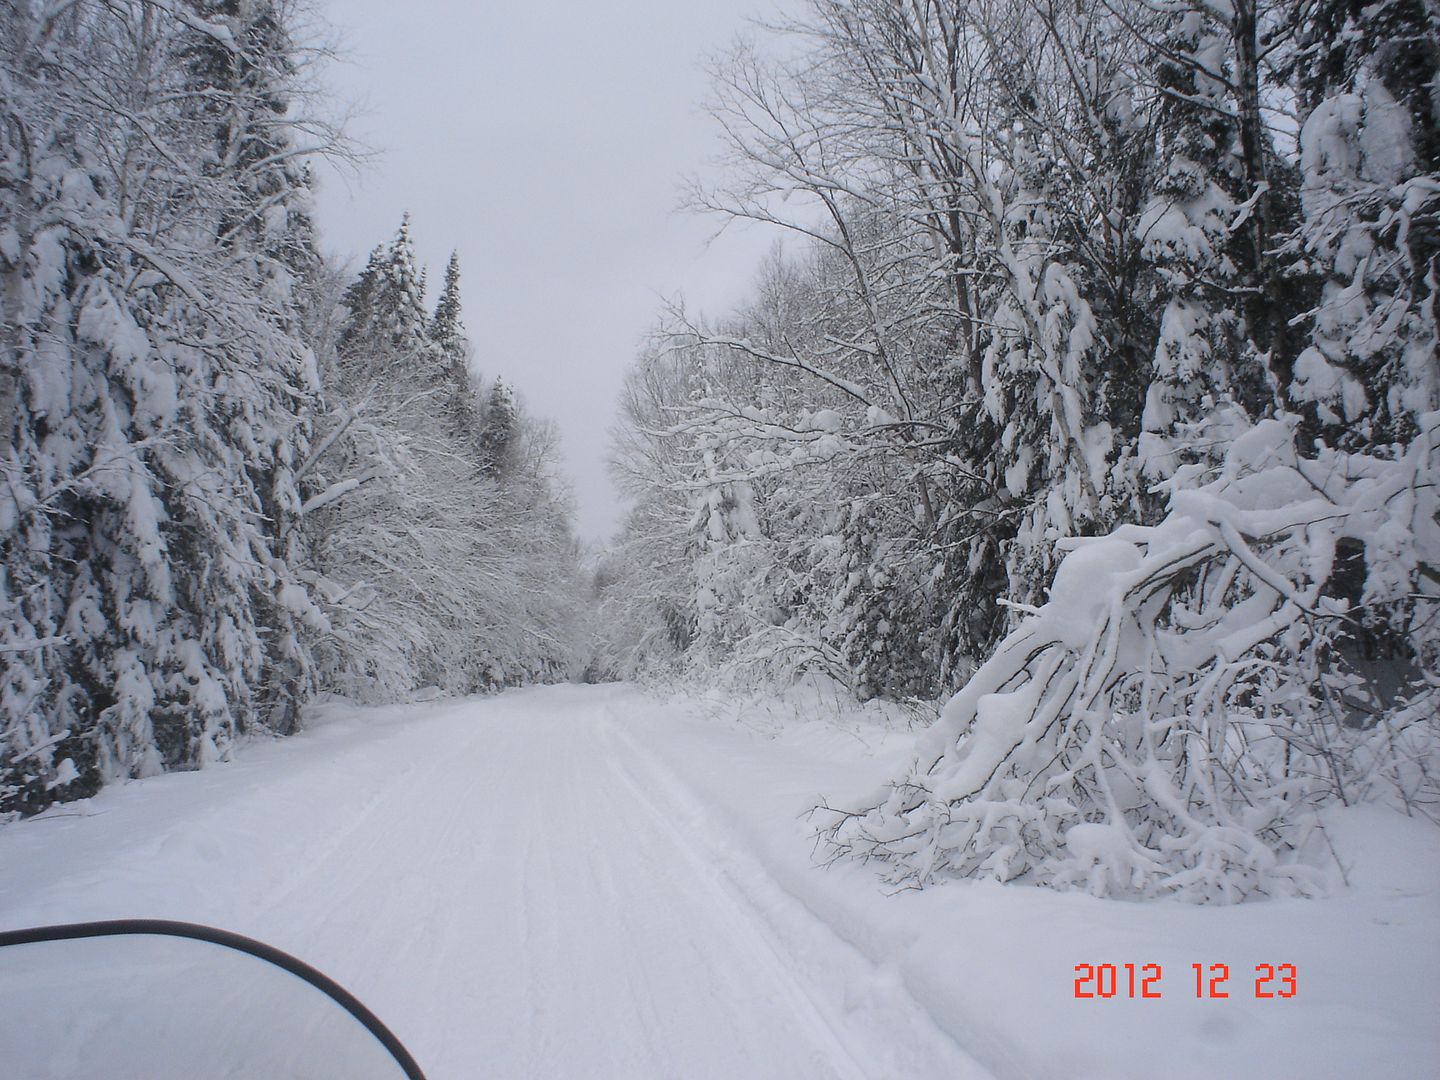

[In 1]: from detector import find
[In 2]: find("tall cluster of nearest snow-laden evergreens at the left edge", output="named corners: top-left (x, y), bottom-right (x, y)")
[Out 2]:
top-left (0, 0), bottom-right (329, 812)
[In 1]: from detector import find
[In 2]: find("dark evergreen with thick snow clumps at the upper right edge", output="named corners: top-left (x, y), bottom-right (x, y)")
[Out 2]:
top-left (1289, 0), bottom-right (1440, 446)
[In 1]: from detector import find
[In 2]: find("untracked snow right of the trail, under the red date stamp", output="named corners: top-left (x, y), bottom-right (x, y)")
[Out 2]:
top-left (624, 688), bottom-right (1440, 1080)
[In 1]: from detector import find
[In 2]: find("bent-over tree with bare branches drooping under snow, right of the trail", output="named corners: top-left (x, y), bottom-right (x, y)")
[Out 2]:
top-left (822, 413), bottom-right (1440, 903)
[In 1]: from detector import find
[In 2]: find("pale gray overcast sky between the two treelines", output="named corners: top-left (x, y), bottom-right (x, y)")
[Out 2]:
top-left (318, 0), bottom-right (776, 539)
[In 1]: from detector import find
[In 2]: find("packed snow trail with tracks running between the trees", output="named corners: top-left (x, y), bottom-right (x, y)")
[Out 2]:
top-left (0, 687), bottom-right (988, 1080)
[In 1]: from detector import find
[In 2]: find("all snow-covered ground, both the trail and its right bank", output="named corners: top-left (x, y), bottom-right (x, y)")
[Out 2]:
top-left (0, 687), bottom-right (1440, 1080)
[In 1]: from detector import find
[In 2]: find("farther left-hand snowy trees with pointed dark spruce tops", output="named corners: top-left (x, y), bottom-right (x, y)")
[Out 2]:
top-left (305, 220), bottom-right (577, 701)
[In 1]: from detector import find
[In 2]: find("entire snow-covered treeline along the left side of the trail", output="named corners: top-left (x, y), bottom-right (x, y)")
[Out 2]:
top-left (0, 0), bottom-right (573, 819)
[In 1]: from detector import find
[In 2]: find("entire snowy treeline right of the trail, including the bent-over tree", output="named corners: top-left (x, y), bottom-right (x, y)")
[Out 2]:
top-left (593, 0), bottom-right (1440, 899)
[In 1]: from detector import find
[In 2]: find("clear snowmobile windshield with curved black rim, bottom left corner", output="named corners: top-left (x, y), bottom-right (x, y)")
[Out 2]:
top-left (0, 920), bottom-right (423, 1080)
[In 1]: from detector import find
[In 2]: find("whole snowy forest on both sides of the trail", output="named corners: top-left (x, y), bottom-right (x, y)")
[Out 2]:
top-left (0, 0), bottom-right (1440, 901)
